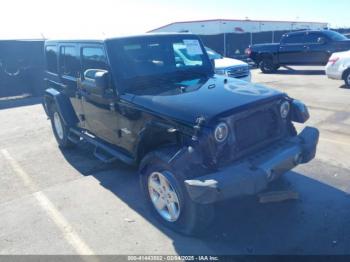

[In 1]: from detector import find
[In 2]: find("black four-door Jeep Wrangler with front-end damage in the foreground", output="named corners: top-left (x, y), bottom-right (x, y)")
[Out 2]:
top-left (44, 34), bottom-right (319, 234)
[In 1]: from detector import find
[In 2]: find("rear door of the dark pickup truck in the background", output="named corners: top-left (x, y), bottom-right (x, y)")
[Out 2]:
top-left (278, 32), bottom-right (308, 65)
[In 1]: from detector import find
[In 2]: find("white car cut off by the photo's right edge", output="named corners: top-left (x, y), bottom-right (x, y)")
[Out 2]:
top-left (326, 51), bottom-right (350, 88)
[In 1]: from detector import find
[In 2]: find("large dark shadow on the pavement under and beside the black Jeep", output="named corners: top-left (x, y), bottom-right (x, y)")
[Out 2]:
top-left (62, 144), bottom-right (350, 255)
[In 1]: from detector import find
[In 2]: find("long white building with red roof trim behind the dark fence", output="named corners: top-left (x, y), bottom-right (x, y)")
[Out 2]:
top-left (150, 19), bottom-right (328, 35)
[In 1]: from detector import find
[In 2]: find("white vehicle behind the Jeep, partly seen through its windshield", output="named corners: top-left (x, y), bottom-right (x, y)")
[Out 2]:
top-left (175, 44), bottom-right (252, 82)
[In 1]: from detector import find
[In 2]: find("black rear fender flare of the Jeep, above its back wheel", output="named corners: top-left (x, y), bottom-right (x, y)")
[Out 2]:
top-left (44, 88), bottom-right (79, 127)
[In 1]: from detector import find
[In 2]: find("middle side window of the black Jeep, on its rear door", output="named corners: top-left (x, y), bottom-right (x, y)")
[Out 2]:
top-left (60, 46), bottom-right (80, 77)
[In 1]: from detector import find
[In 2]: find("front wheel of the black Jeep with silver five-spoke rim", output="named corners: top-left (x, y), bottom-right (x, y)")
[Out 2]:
top-left (140, 152), bottom-right (214, 236)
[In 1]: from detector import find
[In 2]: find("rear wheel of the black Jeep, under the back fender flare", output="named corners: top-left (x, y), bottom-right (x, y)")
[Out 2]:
top-left (50, 105), bottom-right (75, 148)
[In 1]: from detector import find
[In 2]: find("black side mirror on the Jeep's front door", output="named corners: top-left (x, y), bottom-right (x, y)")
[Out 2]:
top-left (84, 69), bottom-right (110, 95)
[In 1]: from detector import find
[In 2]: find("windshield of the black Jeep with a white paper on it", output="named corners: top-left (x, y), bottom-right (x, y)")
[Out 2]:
top-left (107, 35), bottom-right (213, 91)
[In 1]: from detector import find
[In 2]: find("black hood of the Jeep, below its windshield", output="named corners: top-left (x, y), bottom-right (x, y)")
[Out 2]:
top-left (132, 76), bottom-right (285, 125)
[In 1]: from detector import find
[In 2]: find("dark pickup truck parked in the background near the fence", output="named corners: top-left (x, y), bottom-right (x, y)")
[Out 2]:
top-left (247, 30), bottom-right (350, 73)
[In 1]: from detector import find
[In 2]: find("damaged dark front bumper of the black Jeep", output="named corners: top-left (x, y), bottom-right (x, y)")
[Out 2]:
top-left (185, 127), bottom-right (319, 204)
